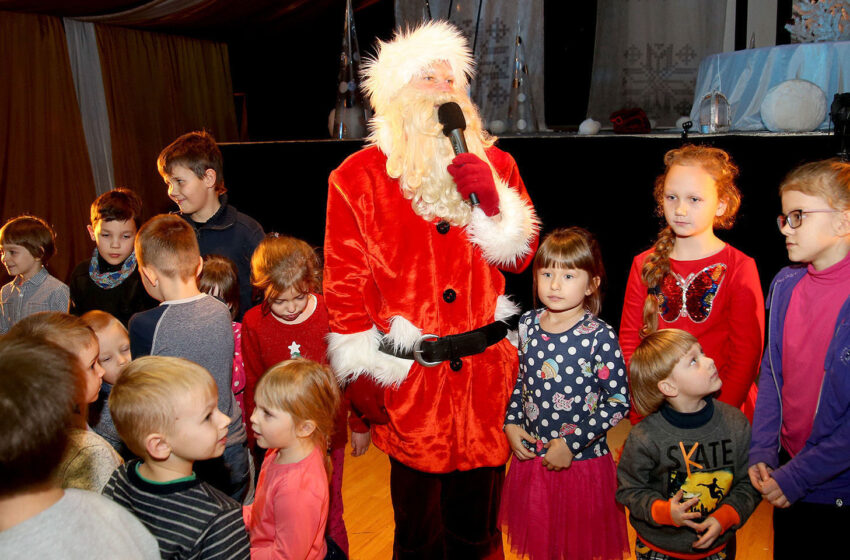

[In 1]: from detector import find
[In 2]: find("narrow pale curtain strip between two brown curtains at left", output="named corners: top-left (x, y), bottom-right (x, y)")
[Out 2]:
top-left (62, 18), bottom-right (114, 195)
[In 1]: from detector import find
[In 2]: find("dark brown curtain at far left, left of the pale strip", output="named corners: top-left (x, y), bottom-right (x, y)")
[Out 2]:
top-left (0, 12), bottom-right (95, 281)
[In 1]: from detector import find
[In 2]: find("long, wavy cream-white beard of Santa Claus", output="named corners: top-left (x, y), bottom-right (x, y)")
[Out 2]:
top-left (369, 87), bottom-right (495, 226)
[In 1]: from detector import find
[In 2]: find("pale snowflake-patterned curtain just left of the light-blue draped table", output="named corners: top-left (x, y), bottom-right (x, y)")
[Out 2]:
top-left (587, 0), bottom-right (734, 128)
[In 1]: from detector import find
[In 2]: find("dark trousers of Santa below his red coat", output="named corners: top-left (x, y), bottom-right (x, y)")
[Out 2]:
top-left (390, 458), bottom-right (505, 560)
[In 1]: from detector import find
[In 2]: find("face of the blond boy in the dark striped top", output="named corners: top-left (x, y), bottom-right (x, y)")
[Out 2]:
top-left (167, 388), bottom-right (230, 463)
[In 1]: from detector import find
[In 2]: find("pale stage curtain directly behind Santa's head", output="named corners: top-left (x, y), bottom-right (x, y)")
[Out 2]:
top-left (395, 0), bottom-right (545, 130)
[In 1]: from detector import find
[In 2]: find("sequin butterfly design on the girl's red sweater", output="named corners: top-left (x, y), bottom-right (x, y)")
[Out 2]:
top-left (653, 263), bottom-right (726, 323)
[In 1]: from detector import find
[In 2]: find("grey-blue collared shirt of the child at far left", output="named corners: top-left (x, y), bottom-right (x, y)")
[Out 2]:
top-left (0, 268), bottom-right (70, 334)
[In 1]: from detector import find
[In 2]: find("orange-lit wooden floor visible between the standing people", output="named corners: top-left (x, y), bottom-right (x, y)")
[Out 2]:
top-left (342, 421), bottom-right (773, 560)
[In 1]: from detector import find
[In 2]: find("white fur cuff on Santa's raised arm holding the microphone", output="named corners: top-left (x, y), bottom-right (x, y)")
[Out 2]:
top-left (466, 179), bottom-right (540, 266)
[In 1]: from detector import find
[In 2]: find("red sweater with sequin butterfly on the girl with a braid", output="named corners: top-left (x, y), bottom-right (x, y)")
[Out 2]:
top-left (620, 245), bottom-right (764, 421)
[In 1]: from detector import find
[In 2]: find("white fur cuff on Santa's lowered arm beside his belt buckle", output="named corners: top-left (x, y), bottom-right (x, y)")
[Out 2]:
top-left (328, 321), bottom-right (413, 387)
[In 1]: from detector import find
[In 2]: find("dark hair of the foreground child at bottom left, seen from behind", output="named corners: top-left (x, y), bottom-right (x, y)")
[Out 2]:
top-left (0, 335), bottom-right (83, 495)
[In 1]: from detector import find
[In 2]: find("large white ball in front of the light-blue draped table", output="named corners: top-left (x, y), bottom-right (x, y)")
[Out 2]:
top-left (761, 80), bottom-right (826, 132)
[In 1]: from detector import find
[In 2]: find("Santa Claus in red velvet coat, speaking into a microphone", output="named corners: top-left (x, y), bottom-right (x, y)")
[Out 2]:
top-left (324, 22), bottom-right (538, 559)
